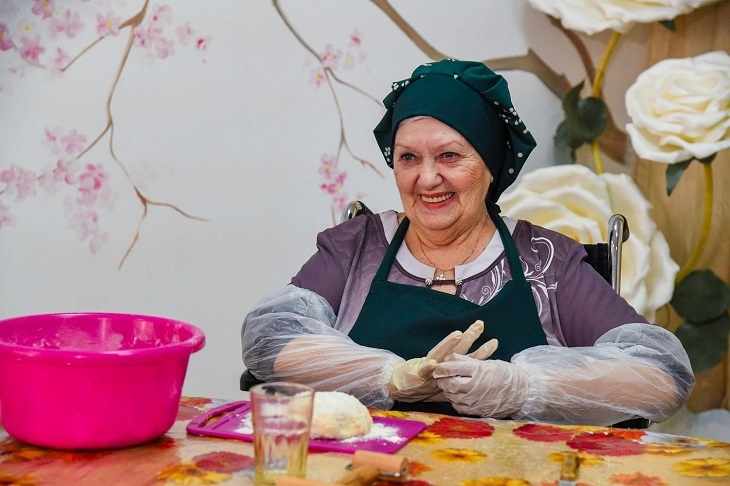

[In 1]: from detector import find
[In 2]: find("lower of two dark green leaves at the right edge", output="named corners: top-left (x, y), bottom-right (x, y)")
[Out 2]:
top-left (675, 312), bottom-right (730, 373)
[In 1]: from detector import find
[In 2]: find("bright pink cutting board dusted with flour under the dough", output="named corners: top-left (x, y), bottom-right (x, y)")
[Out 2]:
top-left (186, 401), bottom-right (426, 454)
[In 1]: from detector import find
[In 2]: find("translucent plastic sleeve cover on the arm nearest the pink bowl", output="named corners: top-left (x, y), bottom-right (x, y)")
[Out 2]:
top-left (241, 284), bottom-right (405, 409)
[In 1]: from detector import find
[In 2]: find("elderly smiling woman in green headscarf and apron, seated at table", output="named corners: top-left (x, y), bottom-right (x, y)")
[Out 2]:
top-left (242, 59), bottom-right (694, 425)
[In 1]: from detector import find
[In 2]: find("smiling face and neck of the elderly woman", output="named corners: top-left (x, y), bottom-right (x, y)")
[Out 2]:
top-left (393, 117), bottom-right (496, 286)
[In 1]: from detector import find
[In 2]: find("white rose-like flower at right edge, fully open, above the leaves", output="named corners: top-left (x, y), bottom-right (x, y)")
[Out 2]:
top-left (626, 51), bottom-right (730, 164)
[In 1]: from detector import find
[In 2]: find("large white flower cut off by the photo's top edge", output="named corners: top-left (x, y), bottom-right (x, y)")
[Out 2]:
top-left (529, 0), bottom-right (717, 35)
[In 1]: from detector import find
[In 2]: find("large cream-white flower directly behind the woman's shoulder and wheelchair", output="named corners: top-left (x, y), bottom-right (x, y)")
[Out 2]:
top-left (499, 165), bottom-right (679, 321)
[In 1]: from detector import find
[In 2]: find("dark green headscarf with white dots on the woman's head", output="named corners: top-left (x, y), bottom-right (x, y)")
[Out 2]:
top-left (374, 59), bottom-right (536, 203)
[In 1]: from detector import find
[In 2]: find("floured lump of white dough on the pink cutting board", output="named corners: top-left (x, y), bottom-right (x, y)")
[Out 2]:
top-left (310, 392), bottom-right (373, 439)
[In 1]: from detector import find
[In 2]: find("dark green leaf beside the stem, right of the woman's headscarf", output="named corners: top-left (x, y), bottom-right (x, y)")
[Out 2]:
top-left (553, 81), bottom-right (608, 150)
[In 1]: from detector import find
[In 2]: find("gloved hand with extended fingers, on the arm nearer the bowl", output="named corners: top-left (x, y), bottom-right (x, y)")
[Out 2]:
top-left (388, 320), bottom-right (497, 402)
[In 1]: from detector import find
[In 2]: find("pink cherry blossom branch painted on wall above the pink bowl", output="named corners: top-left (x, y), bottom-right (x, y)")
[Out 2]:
top-left (0, 0), bottom-right (211, 268)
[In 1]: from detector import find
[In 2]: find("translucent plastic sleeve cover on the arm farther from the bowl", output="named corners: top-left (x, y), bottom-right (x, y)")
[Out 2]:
top-left (511, 323), bottom-right (695, 425)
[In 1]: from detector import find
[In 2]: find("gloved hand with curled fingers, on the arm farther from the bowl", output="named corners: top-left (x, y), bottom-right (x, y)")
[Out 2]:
top-left (433, 355), bottom-right (528, 418)
